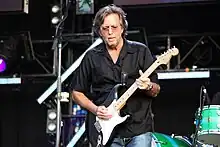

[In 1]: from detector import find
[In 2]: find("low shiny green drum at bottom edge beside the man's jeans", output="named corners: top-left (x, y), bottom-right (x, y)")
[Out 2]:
top-left (151, 133), bottom-right (192, 147)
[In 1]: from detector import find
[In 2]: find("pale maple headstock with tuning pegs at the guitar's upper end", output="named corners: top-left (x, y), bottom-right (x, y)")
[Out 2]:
top-left (157, 46), bottom-right (179, 64)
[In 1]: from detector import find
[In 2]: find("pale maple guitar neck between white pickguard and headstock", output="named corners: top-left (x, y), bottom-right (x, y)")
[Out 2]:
top-left (115, 61), bottom-right (159, 110)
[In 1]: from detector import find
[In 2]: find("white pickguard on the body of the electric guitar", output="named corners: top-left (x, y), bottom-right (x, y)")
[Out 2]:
top-left (96, 100), bottom-right (129, 145)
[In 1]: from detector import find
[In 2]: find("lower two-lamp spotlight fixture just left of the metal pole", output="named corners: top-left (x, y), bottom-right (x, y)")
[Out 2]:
top-left (46, 109), bottom-right (57, 134)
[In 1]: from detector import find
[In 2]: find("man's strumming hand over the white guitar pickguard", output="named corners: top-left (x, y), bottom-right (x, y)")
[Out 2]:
top-left (96, 106), bottom-right (112, 120)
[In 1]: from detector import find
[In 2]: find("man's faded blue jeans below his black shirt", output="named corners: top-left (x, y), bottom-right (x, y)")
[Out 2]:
top-left (110, 132), bottom-right (152, 147)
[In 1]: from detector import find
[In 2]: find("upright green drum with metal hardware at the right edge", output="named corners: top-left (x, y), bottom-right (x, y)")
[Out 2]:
top-left (196, 105), bottom-right (220, 145)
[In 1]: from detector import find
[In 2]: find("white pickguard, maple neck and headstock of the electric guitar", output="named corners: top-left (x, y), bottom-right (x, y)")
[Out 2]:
top-left (94, 47), bottom-right (179, 145)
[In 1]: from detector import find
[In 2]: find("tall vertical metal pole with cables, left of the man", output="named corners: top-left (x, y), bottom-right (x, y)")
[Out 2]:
top-left (52, 0), bottom-right (71, 147)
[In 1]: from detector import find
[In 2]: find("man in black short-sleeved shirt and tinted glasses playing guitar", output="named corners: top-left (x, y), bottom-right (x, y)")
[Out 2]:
top-left (71, 5), bottom-right (160, 147)
